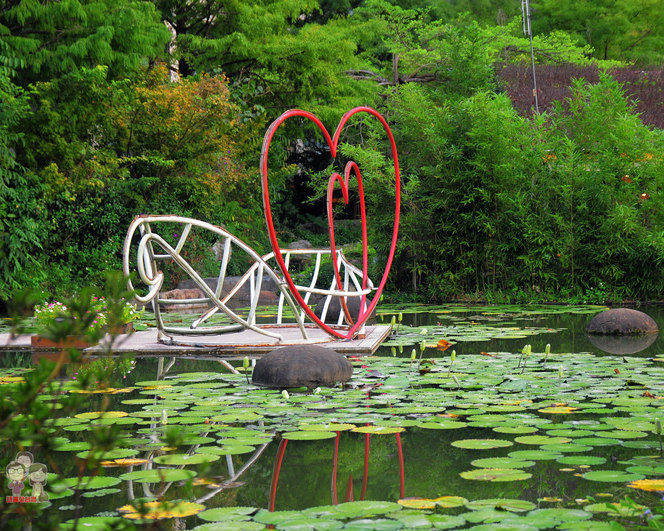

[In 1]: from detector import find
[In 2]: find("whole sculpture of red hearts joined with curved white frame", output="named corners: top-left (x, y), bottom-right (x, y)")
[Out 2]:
top-left (123, 107), bottom-right (401, 348)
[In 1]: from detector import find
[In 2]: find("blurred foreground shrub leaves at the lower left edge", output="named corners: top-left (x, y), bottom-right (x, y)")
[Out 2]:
top-left (0, 277), bottom-right (135, 530)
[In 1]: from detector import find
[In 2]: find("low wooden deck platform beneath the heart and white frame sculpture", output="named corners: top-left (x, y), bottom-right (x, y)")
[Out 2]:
top-left (0, 325), bottom-right (391, 359)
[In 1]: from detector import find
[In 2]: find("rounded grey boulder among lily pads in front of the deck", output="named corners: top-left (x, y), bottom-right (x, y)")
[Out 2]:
top-left (251, 345), bottom-right (353, 389)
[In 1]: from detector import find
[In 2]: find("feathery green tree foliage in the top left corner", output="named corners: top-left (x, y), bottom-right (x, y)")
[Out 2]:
top-left (0, 0), bottom-right (169, 86)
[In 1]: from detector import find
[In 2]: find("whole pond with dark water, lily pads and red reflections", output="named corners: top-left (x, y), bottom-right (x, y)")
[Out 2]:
top-left (0, 306), bottom-right (664, 531)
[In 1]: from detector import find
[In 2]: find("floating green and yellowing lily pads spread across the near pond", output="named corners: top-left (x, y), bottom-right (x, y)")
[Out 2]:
top-left (5, 306), bottom-right (664, 531)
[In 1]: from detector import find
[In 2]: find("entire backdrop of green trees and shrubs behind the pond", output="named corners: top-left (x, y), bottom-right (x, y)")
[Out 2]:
top-left (0, 0), bottom-right (664, 304)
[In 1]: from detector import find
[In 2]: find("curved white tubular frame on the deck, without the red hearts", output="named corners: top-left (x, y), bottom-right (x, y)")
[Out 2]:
top-left (123, 215), bottom-right (374, 344)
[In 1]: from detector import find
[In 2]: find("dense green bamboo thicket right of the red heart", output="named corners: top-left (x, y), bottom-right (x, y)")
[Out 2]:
top-left (370, 66), bottom-right (664, 299)
